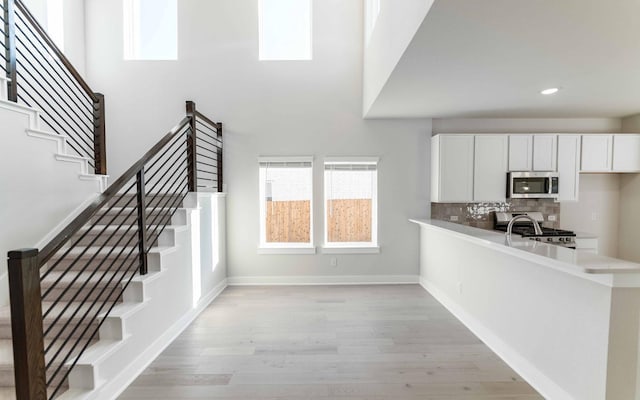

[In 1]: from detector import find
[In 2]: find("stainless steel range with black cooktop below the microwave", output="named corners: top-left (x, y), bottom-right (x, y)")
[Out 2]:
top-left (494, 211), bottom-right (576, 249)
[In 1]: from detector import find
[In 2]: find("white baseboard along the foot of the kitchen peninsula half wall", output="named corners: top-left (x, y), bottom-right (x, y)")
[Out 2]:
top-left (420, 277), bottom-right (575, 400)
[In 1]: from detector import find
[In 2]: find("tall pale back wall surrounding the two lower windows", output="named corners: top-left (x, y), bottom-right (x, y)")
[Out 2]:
top-left (86, 0), bottom-right (431, 281)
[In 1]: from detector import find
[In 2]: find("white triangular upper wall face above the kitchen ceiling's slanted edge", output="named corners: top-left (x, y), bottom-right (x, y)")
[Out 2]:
top-left (363, 0), bottom-right (434, 115)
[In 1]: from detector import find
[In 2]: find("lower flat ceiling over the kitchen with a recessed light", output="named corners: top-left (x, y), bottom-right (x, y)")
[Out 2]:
top-left (366, 0), bottom-right (640, 118)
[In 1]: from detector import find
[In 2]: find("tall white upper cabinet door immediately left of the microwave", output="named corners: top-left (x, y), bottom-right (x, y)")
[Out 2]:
top-left (473, 135), bottom-right (509, 202)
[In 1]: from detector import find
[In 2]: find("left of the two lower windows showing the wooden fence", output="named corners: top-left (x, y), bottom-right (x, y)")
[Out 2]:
top-left (259, 157), bottom-right (315, 253)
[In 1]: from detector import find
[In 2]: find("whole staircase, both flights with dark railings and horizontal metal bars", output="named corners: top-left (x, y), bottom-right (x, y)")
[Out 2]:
top-left (0, 0), bottom-right (226, 400)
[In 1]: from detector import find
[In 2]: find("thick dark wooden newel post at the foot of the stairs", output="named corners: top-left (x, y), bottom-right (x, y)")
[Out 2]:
top-left (9, 249), bottom-right (47, 400)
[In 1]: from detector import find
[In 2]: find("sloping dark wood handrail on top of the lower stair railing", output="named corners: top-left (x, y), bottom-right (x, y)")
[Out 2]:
top-left (38, 116), bottom-right (191, 265)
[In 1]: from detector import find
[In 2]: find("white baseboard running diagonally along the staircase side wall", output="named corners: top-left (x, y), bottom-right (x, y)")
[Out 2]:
top-left (86, 279), bottom-right (227, 400)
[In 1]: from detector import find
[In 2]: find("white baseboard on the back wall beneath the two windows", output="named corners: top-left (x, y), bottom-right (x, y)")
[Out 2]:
top-left (228, 275), bottom-right (419, 286)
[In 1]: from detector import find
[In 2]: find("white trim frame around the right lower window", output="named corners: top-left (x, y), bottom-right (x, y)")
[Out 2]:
top-left (322, 156), bottom-right (380, 250)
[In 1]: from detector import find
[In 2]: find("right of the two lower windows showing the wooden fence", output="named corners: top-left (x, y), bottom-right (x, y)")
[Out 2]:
top-left (324, 157), bottom-right (378, 252)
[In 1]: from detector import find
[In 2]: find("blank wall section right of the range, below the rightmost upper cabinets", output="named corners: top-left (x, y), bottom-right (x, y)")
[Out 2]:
top-left (560, 174), bottom-right (624, 258)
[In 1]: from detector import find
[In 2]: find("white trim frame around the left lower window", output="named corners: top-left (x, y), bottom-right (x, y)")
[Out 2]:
top-left (258, 156), bottom-right (316, 254)
